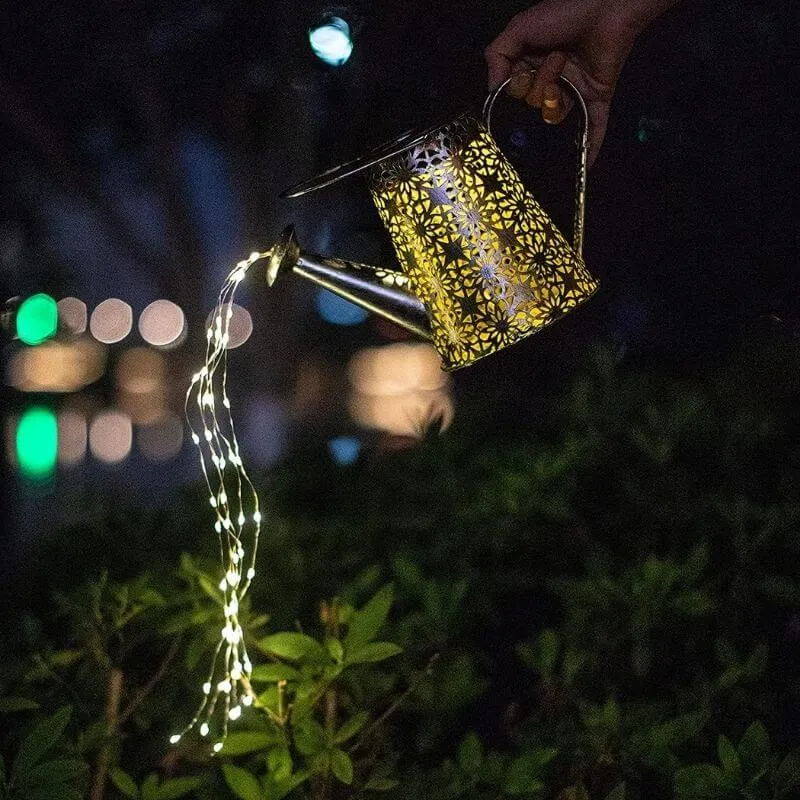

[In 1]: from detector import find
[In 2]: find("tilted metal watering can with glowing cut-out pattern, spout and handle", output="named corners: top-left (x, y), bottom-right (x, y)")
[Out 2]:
top-left (267, 72), bottom-right (598, 371)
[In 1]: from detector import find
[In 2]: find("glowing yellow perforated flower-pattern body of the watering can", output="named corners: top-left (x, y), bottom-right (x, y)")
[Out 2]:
top-left (372, 117), bottom-right (597, 370)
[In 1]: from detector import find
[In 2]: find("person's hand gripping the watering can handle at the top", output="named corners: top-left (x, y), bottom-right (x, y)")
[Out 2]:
top-left (485, 0), bottom-right (677, 165)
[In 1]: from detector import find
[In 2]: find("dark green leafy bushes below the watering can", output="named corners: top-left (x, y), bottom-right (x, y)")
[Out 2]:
top-left (0, 346), bottom-right (800, 800)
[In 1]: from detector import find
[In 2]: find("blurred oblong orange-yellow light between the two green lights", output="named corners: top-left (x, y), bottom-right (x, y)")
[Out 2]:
top-left (8, 338), bottom-right (105, 392)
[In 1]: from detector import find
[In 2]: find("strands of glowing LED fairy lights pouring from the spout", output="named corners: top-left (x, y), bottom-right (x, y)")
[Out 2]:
top-left (177, 252), bottom-right (270, 753)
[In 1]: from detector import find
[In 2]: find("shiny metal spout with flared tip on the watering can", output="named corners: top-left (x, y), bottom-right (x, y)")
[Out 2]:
top-left (267, 225), bottom-right (432, 339)
